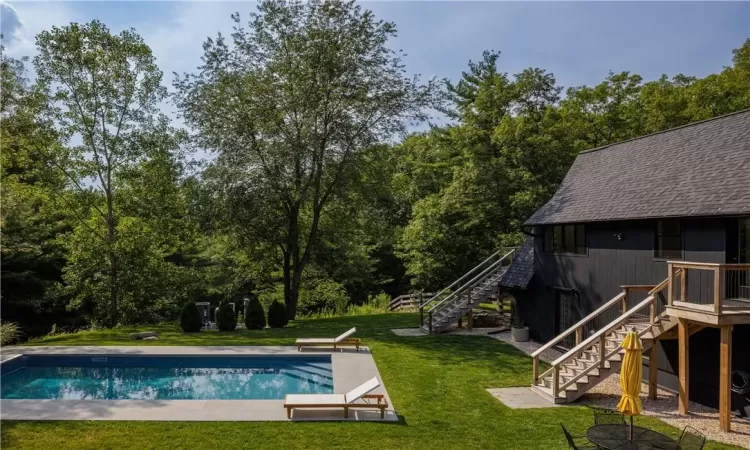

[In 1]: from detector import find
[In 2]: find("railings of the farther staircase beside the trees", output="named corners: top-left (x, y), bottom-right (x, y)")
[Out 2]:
top-left (419, 248), bottom-right (517, 331)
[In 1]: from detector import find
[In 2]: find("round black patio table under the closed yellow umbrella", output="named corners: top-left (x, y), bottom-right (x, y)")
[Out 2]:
top-left (586, 424), bottom-right (680, 450)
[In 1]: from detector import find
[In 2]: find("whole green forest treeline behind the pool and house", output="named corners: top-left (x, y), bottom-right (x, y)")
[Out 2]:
top-left (0, 1), bottom-right (750, 334)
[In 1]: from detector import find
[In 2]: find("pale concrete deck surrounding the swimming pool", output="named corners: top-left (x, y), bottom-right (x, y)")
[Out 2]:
top-left (0, 346), bottom-right (398, 422)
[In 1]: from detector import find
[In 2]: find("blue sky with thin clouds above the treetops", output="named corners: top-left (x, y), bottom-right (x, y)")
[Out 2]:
top-left (0, 1), bottom-right (750, 113)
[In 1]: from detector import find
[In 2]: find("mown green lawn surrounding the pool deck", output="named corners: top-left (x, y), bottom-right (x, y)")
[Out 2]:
top-left (2, 313), bottom-right (735, 450)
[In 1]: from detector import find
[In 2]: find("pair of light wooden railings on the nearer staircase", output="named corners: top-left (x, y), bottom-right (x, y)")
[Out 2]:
top-left (531, 273), bottom-right (679, 397)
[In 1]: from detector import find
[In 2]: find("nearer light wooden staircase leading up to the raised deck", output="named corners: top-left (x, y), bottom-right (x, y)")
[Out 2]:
top-left (531, 270), bottom-right (702, 404)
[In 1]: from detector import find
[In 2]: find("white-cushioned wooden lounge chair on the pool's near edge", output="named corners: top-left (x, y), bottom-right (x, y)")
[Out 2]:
top-left (284, 378), bottom-right (388, 419)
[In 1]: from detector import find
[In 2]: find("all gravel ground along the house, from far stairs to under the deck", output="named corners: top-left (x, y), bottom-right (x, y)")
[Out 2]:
top-left (449, 328), bottom-right (750, 449)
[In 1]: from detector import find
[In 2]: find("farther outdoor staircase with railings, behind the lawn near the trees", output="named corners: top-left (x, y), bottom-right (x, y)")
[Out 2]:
top-left (419, 249), bottom-right (516, 333)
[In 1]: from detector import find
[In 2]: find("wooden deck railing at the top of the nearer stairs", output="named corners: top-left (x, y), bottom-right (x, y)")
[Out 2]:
top-left (667, 261), bottom-right (750, 314)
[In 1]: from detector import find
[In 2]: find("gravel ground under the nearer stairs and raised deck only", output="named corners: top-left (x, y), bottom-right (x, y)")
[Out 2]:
top-left (579, 374), bottom-right (750, 448)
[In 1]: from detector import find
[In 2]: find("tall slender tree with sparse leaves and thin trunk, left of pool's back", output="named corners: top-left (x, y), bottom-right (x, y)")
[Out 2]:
top-left (34, 20), bottom-right (167, 326)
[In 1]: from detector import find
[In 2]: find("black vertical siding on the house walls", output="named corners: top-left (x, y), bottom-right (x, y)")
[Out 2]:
top-left (519, 219), bottom-right (750, 409)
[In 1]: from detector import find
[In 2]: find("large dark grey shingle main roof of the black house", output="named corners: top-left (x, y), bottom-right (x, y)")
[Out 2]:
top-left (526, 110), bottom-right (750, 225)
